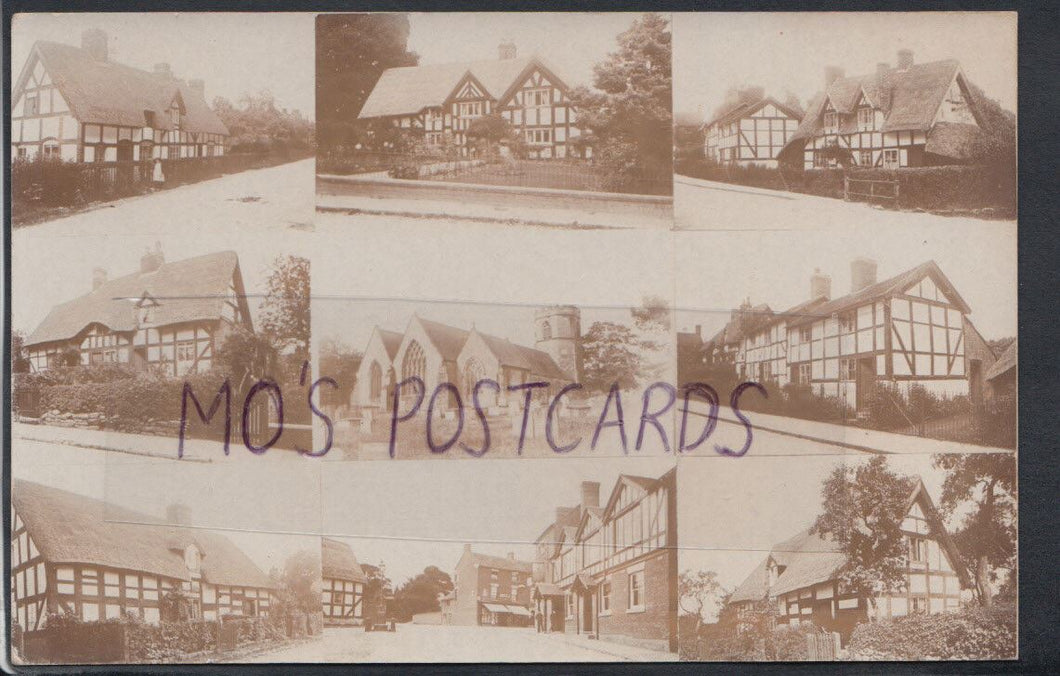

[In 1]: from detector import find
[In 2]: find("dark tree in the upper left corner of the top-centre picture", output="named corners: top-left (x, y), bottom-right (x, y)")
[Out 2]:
top-left (316, 13), bottom-right (420, 147)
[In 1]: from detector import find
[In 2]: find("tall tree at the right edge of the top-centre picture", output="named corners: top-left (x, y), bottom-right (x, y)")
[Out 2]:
top-left (571, 14), bottom-right (673, 192)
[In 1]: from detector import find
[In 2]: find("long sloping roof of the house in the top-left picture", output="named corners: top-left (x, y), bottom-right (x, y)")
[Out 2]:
top-left (34, 40), bottom-right (228, 136)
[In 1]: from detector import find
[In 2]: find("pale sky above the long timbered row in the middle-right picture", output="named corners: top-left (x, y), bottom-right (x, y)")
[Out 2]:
top-left (674, 221), bottom-right (1018, 340)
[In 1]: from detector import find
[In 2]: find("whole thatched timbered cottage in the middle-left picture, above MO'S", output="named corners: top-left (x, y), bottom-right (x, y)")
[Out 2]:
top-left (24, 246), bottom-right (252, 376)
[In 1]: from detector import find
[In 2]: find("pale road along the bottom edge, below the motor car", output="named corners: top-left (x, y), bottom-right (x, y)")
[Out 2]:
top-left (232, 624), bottom-right (676, 663)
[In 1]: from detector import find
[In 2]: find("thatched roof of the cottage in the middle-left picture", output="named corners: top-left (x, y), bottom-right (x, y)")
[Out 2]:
top-left (25, 251), bottom-right (239, 346)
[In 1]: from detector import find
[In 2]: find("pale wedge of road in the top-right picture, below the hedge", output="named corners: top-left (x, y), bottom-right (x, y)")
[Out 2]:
top-left (673, 175), bottom-right (1011, 231)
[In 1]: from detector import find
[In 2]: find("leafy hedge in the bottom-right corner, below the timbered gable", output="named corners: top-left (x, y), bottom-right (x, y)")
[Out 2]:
top-left (848, 605), bottom-right (1017, 660)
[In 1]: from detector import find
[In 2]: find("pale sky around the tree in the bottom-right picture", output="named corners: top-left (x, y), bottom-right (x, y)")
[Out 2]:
top-left (677, 453), bottom-right (975, 623)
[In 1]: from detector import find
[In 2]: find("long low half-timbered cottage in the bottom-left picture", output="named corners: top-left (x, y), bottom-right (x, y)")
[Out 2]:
top-left (11, 479), bottom-right (273, 631)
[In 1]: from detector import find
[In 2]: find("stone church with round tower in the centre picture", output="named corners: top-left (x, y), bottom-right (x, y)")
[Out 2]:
top-left (350, 305), bottom-right (582, 420)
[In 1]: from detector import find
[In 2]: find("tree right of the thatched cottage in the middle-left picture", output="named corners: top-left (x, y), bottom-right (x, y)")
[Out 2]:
top-left (261, 254), bottom-right (310, 376)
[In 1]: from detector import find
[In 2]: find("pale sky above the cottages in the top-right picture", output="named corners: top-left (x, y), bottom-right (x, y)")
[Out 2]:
top-left (673, 12), bottom-right (1017, 122)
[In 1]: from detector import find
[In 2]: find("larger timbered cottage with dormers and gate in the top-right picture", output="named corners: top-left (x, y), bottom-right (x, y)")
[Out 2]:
top-left (783, 50), bottom-right (982, 168)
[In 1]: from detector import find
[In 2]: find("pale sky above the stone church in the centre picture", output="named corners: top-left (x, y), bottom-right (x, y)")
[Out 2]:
top-left (312, 223), bottom-right (673, 360)
